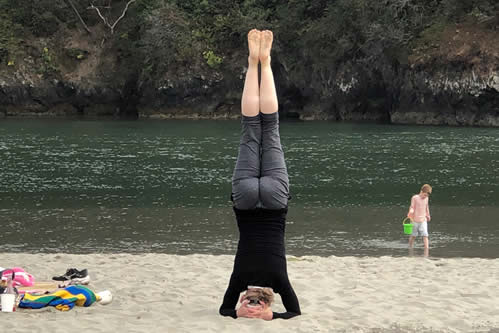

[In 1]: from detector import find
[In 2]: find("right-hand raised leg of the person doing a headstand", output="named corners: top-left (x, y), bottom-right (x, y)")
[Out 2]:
top-left (260, 30), bottom-right (289, 209)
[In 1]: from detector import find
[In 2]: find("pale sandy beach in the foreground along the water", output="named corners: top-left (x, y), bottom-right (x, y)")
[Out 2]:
top-left (0, 253), bottom-right (499, 333)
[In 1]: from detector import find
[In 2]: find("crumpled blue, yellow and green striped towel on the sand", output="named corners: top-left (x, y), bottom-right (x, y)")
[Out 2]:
top-left (19, 285), bottom-right (98, 311)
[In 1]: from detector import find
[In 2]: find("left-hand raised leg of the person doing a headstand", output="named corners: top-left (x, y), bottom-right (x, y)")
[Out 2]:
top-left (232, 29), bottom-right (262, 209)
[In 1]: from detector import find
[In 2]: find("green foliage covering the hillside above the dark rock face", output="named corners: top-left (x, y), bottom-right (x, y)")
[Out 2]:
top-left (0, 0), bottom-right (499, 84)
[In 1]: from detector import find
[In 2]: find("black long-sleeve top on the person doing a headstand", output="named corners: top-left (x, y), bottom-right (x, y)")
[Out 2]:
top-left (220, 208), bottom-right (301, 319)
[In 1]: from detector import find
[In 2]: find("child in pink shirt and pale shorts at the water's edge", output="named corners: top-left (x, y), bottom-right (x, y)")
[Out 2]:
top-left (407, 184), bottom-right (431, 252)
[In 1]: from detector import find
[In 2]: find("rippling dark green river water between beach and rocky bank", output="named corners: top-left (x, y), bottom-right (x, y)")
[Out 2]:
top-left (0, 120), bottom-right (499, 258)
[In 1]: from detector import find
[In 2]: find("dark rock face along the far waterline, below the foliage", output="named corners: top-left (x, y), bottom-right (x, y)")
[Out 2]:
top-left (0, 22), bottom-right (499, 127)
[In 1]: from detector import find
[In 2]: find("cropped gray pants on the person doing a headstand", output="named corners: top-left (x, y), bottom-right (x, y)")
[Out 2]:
top-left (232, 112), bottom-right (289, 209)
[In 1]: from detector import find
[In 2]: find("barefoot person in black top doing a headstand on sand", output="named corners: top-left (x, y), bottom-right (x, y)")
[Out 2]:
top-left (220, 29), bottom-right (301, 320)
